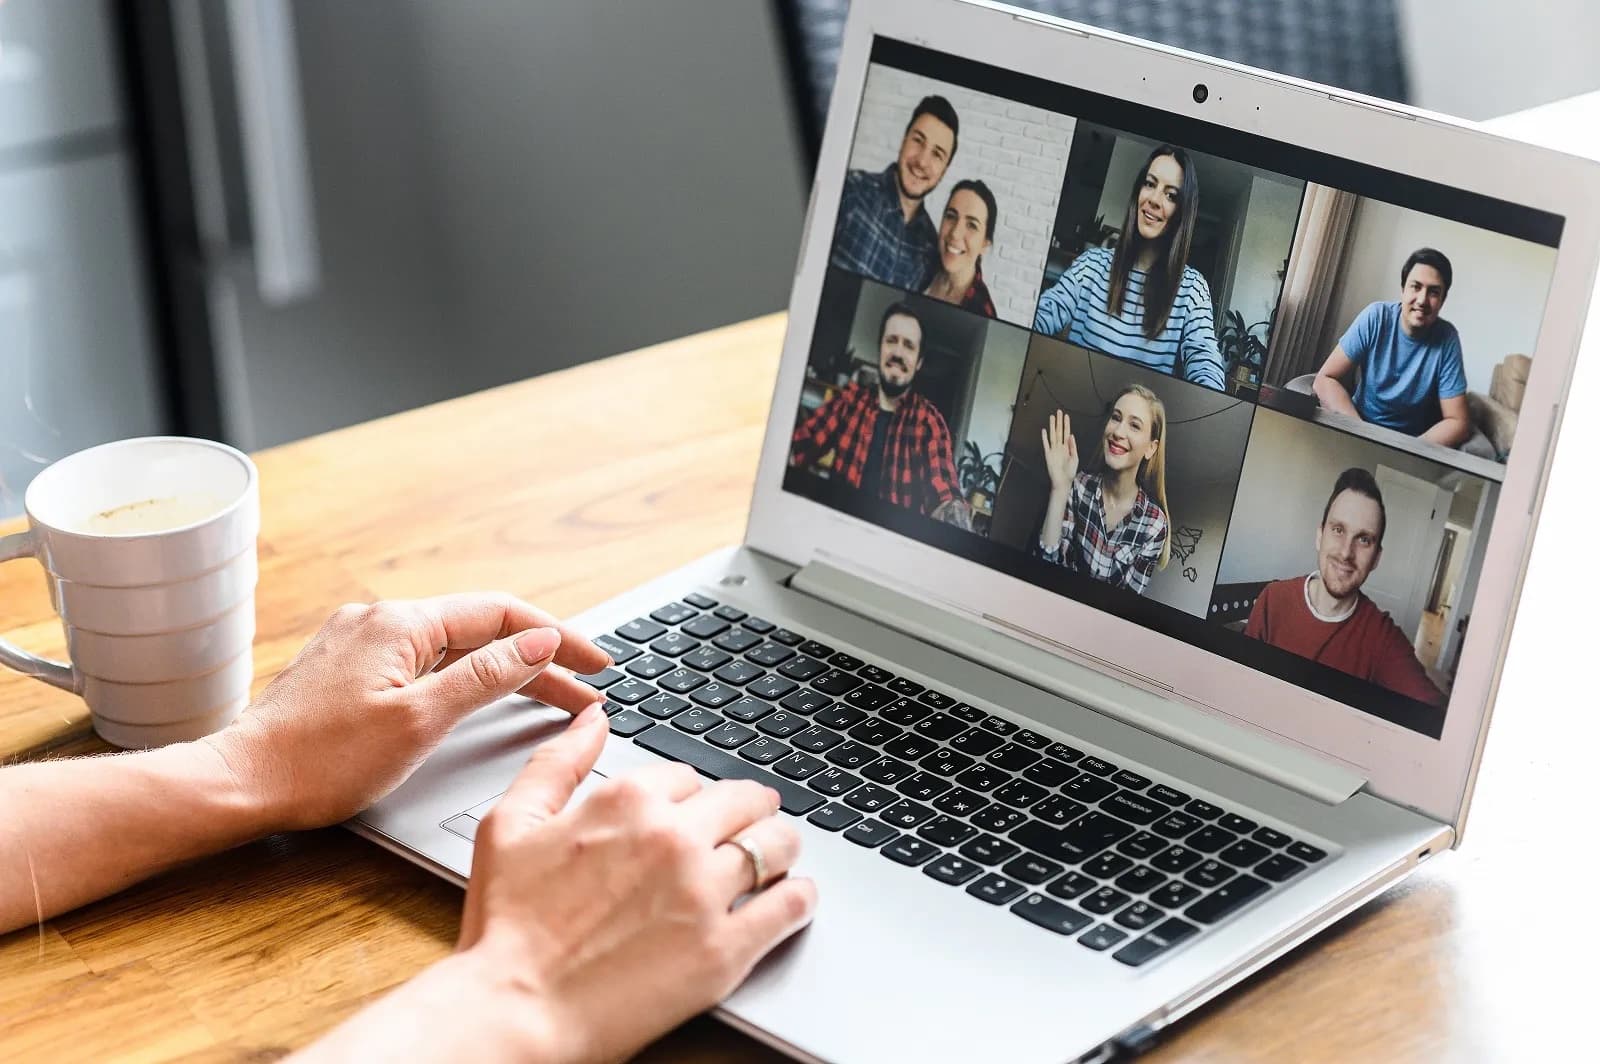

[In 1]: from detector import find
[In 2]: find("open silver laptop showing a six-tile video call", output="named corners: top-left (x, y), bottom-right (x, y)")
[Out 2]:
top-left (352, 0), bottom-right (1600, 1061)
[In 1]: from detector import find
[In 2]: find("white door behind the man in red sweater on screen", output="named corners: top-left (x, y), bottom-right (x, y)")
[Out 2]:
top-left (1362, 466), bottom-right (1450, 640)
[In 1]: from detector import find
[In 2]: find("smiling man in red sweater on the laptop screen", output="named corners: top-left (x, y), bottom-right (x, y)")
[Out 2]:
top-left (1245, 469), bottom-right (1445, 707)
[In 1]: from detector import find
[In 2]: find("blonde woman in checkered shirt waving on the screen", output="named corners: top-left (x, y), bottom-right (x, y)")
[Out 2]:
top-left (1038, 384), bottom-right (1173, 595)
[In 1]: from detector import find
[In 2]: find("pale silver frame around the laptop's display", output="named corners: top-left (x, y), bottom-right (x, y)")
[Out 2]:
top-left (746, 0), bottom-right (1600, 826)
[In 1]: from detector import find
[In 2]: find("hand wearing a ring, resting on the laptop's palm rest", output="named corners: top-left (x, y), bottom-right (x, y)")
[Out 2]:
top-left (458, 707), bottom-right (816, 1061)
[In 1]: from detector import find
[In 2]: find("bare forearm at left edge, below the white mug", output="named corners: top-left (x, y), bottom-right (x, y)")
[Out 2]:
top-left (0, 742), bottom-right (272, 931)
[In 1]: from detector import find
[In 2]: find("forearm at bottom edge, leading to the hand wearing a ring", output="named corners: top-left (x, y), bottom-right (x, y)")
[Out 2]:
top-left (290, 949), bottom-right (560, 1064)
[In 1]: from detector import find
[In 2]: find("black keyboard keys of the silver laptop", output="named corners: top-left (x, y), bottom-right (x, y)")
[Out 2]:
top-left (572, 594), bottom-right (1328, 966)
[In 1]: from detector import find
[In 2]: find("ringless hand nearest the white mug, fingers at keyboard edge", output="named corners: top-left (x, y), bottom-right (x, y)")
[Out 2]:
top-left (203, 594), bottom-right (610, 830)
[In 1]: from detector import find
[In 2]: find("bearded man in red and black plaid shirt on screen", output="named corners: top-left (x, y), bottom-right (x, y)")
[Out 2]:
top-left (789, 302), bottom-right (966, 525)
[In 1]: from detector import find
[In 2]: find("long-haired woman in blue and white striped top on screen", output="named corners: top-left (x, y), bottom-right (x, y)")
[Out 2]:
top-left (1034, 144), bottom-right (1224, 390)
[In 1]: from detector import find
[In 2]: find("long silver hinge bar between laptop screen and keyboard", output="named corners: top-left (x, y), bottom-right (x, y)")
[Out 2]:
top-left (789, 560), bottom-right (1366, 805)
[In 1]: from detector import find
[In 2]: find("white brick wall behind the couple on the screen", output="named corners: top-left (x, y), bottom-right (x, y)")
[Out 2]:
top-left (850, 66), bottom-right (1075, 325)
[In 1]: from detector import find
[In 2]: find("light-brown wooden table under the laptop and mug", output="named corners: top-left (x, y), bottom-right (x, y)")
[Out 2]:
top-left (0, 96), bottom-right (1600, 1064)
